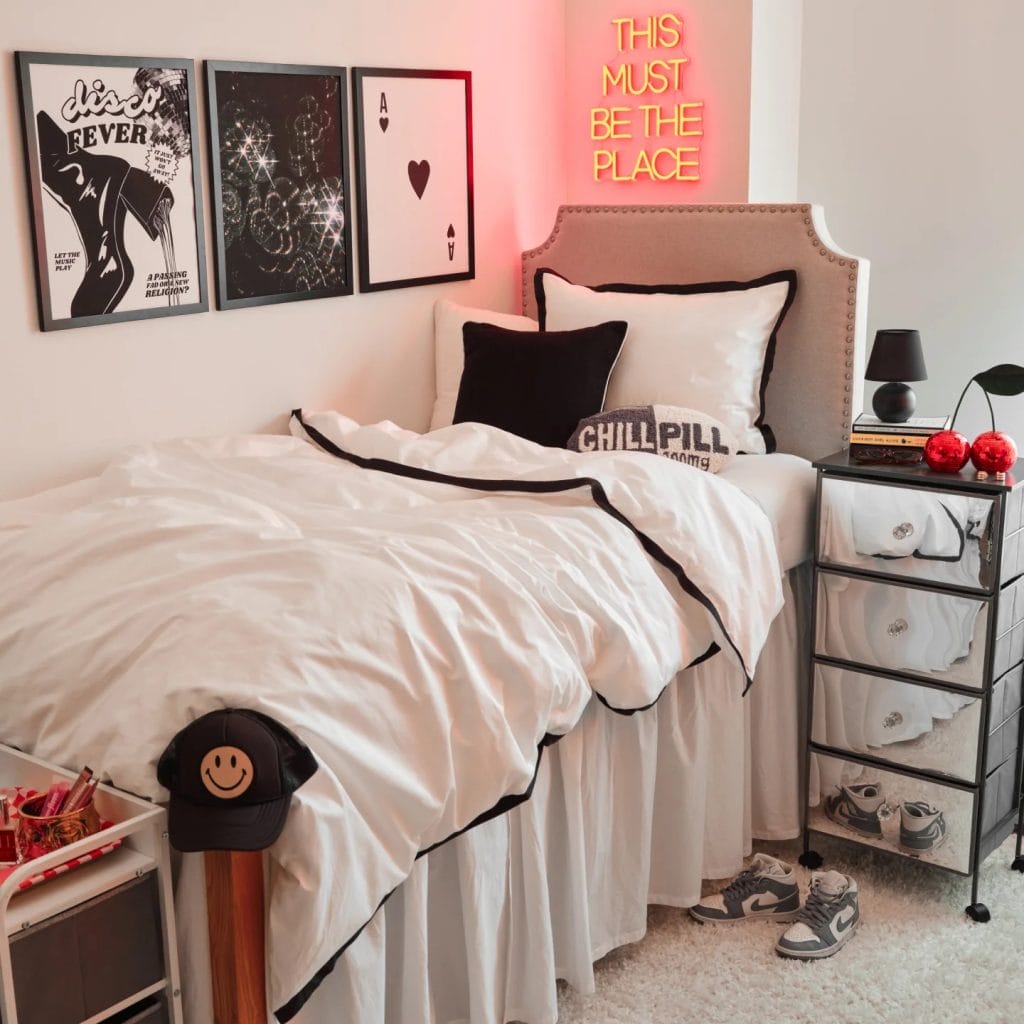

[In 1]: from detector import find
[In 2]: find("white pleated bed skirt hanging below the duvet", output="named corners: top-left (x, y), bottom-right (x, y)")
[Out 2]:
top-left (176, 564), bottom-right (810, 1024)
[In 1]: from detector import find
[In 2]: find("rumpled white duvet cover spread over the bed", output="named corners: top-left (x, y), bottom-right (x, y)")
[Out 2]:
top-left (0, 414), bottom-right (782, 1018)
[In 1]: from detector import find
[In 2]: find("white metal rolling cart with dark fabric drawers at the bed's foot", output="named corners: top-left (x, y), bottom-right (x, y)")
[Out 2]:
top-left (0, 745), bottom-right (182, 1024)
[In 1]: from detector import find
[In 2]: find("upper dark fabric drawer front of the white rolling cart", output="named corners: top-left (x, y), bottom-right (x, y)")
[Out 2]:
top-left (10, 871), bottom-right (164, 1024)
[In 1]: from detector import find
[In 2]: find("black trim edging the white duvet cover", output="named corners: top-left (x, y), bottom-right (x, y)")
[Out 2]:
top-left (274, 409), bottom-right (753, 1024)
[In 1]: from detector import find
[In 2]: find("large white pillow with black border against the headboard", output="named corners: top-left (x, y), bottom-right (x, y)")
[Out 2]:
top-left (536, 268), bottom-right (797, 455)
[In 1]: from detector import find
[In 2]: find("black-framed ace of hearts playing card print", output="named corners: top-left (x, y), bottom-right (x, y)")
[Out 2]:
top-left (352, 68), bottom-right (475, 292)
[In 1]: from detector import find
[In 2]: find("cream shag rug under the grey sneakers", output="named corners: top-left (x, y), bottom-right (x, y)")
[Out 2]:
top-left (558, 837), bottom-right (1024, 1024)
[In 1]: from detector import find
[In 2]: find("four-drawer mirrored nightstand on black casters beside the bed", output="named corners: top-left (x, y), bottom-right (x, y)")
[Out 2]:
top-left (800, 452), bottom-right (1024, 921)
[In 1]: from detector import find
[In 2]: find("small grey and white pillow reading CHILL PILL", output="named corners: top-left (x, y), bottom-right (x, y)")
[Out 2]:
top-left (566, 406), bottom-right (737, 473)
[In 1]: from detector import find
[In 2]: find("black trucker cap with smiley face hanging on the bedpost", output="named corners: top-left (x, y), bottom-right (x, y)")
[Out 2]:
top-left (157, 708), bottom-right (316, 852)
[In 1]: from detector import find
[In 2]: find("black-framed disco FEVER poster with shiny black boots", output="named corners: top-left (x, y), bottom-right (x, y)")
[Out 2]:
top-left (16, 52), bottom-right (207, 331)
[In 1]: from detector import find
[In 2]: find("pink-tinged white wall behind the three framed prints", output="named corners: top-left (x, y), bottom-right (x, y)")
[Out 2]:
top-left (0, 0), bottom-right (565, 497)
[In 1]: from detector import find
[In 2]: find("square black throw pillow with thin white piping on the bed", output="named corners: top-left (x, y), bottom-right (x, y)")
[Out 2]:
top-left (453, 321), bottom-right (628, 447)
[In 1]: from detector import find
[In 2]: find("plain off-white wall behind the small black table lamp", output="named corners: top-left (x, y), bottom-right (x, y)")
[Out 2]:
top-left (799, 0), bottom-right (1024, 451)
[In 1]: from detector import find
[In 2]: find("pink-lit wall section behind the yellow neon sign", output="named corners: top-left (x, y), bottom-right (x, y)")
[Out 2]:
top-left (564, 0), bottom-right (752, 203)
